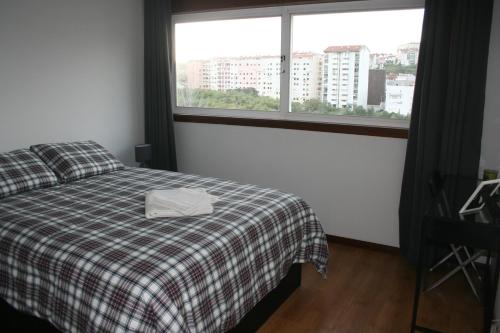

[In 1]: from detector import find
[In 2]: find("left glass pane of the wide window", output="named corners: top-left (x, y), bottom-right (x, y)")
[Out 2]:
top-left (175, 17), bottom-right (281, 111)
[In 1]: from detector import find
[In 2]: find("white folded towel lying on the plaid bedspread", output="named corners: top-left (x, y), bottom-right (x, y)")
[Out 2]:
top-left (146, 188), bottom-right (219, 219)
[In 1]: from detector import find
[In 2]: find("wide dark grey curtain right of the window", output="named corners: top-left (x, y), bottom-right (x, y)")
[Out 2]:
top-left (399, 0), bottom-right (493, 261)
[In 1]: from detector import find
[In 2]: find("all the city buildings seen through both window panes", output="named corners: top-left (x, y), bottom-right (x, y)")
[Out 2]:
top-left (178, 43), bottom-right (419, 115)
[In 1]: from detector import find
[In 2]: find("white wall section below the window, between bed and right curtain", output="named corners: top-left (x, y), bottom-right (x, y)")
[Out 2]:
top-left (175, 123), bottom-right (406, 246)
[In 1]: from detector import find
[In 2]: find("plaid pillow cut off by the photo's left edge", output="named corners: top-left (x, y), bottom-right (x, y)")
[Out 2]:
top-left (0, 149), bottom-right (57, 199)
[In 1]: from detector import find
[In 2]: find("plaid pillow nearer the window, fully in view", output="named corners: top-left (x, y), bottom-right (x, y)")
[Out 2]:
top-left (30, 141), bottom-right (124, 183)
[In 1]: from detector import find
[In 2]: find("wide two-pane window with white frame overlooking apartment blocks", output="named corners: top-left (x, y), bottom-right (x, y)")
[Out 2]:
top-left (174, 0), bottom-right (424, 127)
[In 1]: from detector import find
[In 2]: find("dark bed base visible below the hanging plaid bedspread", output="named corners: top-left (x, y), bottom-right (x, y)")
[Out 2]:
top-left (0, 264), bottom-right (302, 333)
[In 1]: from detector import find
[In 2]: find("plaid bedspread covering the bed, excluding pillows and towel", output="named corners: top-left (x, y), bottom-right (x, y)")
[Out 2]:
top-left (0, 168), bottom-right (328, 332)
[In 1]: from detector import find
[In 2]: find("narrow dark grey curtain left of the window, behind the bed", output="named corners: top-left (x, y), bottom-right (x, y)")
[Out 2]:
top-left (144, 0), bottom-right (177, 171)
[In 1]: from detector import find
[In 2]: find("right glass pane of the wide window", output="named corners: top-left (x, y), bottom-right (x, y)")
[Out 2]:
top-left (290, 9), bottom-right (424, 119)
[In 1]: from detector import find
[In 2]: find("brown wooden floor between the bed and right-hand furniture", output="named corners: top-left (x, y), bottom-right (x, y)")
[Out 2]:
top-left (259, 243), bottom-right (482, 333)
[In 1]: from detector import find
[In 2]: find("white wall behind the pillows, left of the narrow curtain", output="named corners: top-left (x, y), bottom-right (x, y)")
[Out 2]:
top-left (0, 0), bottom-right (144, 163)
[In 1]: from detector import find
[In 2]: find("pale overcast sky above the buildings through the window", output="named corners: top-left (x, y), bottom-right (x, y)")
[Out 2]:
top-left (175, 9), bottom-right (424, 63)
